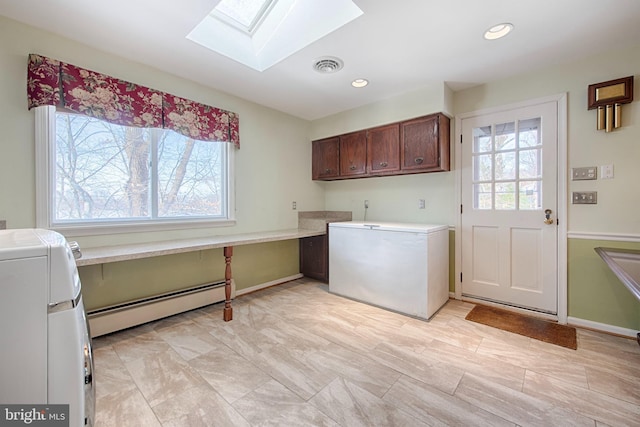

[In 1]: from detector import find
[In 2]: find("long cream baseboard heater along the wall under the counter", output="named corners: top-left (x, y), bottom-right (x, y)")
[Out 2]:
top-left (87, 280), bottom-right (236, 337)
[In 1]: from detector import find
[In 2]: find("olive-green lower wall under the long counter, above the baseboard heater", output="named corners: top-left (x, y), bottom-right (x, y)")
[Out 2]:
top-left (78, 240), bottom-right (300, 311)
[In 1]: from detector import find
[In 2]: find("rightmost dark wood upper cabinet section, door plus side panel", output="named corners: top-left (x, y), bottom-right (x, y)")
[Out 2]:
top-left (400, 114), bottom-right (449, 171)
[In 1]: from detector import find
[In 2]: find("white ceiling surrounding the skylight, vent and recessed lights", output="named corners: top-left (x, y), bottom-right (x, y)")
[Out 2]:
top-left (0, 0), bottom-right (640, 120)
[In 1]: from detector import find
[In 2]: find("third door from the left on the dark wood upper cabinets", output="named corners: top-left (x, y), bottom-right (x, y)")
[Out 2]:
top-left (367, 123), bottom-right (400, 174)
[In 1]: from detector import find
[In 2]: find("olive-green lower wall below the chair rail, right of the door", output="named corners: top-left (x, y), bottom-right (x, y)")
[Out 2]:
top-left (567, 239), bottom-right (640, 330)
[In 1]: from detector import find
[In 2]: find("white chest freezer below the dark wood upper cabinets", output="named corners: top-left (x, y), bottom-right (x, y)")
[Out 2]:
top-left (329, 221), bottom-right (449, 319)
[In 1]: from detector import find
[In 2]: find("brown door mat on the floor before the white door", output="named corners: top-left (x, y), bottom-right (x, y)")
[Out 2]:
top-left (465, 305), bottom-right (578, 350)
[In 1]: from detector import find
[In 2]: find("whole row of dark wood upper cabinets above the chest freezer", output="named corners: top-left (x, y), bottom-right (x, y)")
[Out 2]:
top-left (312, 113), bottom-right (451, 180)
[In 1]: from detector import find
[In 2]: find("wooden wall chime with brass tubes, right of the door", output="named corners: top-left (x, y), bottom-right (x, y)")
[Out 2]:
top-left (588, 76), bottom-right (633, 132)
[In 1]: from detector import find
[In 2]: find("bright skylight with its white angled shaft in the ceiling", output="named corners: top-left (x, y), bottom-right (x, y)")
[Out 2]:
top-left (187, 0), bottom-right (362, 71)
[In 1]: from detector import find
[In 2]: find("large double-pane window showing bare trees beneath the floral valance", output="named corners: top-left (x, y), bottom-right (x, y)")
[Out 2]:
top-left (36, 106), bottom-right (233, 234)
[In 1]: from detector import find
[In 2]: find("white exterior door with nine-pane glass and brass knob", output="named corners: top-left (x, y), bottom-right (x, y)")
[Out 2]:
top-left (461, 102), bottom-right (558, 314)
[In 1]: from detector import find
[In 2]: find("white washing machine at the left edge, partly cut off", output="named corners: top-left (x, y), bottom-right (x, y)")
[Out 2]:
top-left (0, 229), bottom-right (95, 427)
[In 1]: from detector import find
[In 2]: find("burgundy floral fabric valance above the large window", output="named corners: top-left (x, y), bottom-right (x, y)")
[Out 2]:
top-left (27, 54), bottom-right (240, 148)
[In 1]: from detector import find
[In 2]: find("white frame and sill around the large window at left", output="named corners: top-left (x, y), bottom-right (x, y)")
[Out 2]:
top-left (34, 106), bottom-right (236, 236)
